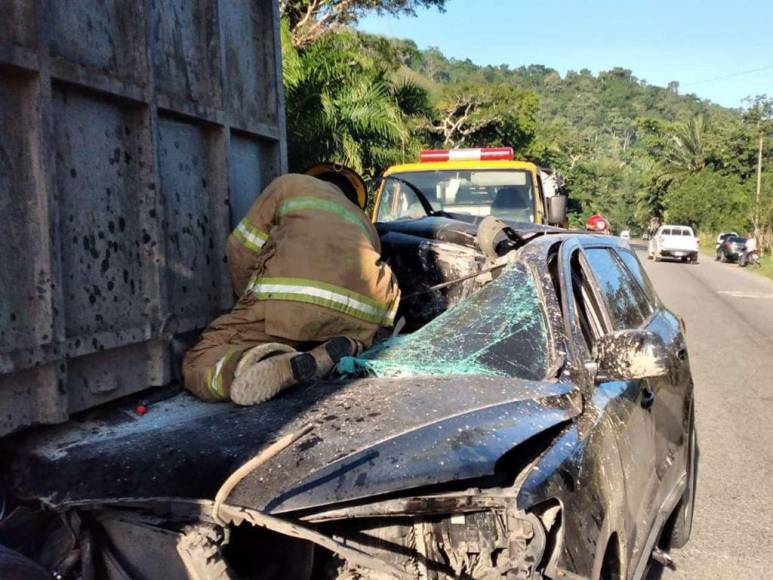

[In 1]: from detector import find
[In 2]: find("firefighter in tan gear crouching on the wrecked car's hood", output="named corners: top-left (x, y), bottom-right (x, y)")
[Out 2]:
top-left (183, 168), bottom-right (400, 405)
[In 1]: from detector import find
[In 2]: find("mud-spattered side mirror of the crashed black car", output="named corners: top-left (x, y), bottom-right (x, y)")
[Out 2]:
top-left (593, 330), bottom-right (668, 382)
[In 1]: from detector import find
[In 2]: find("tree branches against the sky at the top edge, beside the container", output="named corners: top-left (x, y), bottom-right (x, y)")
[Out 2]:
top-left (279, 0), bottom-right (446, 48)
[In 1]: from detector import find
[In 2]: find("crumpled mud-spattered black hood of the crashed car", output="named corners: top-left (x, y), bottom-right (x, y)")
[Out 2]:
top-left (11, 376), bottom-right (580, 512)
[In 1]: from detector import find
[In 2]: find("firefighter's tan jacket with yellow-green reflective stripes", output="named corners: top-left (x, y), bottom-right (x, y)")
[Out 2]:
top-left (227, 175), bottom-right (400, 344)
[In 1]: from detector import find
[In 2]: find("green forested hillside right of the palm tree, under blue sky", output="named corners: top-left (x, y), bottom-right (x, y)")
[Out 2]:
top-left (388, 40), bottom-right (773, 238)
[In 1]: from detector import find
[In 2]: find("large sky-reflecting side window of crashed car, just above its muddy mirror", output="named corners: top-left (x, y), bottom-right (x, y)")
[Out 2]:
top-left (585, 248), bottom-right (649, 330)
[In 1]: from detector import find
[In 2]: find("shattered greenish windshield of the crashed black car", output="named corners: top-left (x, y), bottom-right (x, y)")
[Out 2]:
top-left (339, 264), bottom-right (550, 380)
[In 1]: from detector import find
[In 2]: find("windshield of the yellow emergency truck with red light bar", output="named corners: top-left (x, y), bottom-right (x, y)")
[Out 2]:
top-left (376, 169), bottom-right (534, 222)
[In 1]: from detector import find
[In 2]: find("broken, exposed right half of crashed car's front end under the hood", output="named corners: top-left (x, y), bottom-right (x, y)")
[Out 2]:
top-left (303, 490), bottom-right (547, 578)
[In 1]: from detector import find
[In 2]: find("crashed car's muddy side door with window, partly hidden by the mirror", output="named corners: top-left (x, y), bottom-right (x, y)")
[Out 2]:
top-left (583, 245), bottom-right (659, 562)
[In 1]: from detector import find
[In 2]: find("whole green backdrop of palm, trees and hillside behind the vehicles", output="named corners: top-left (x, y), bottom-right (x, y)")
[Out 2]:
top-left (283, 0), bottom-right (773, 242)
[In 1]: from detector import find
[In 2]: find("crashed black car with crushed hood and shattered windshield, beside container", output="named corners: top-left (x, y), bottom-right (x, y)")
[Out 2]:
top-left (0, 215), bottom-right (697, 579)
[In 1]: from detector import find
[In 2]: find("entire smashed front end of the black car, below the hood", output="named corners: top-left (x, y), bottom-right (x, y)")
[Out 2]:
top-left (0, 489), bottom-right (560, 580)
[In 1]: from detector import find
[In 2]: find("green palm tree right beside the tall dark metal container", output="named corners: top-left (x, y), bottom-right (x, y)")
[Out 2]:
top-left (283, 26), bottom-right (429, 177)
